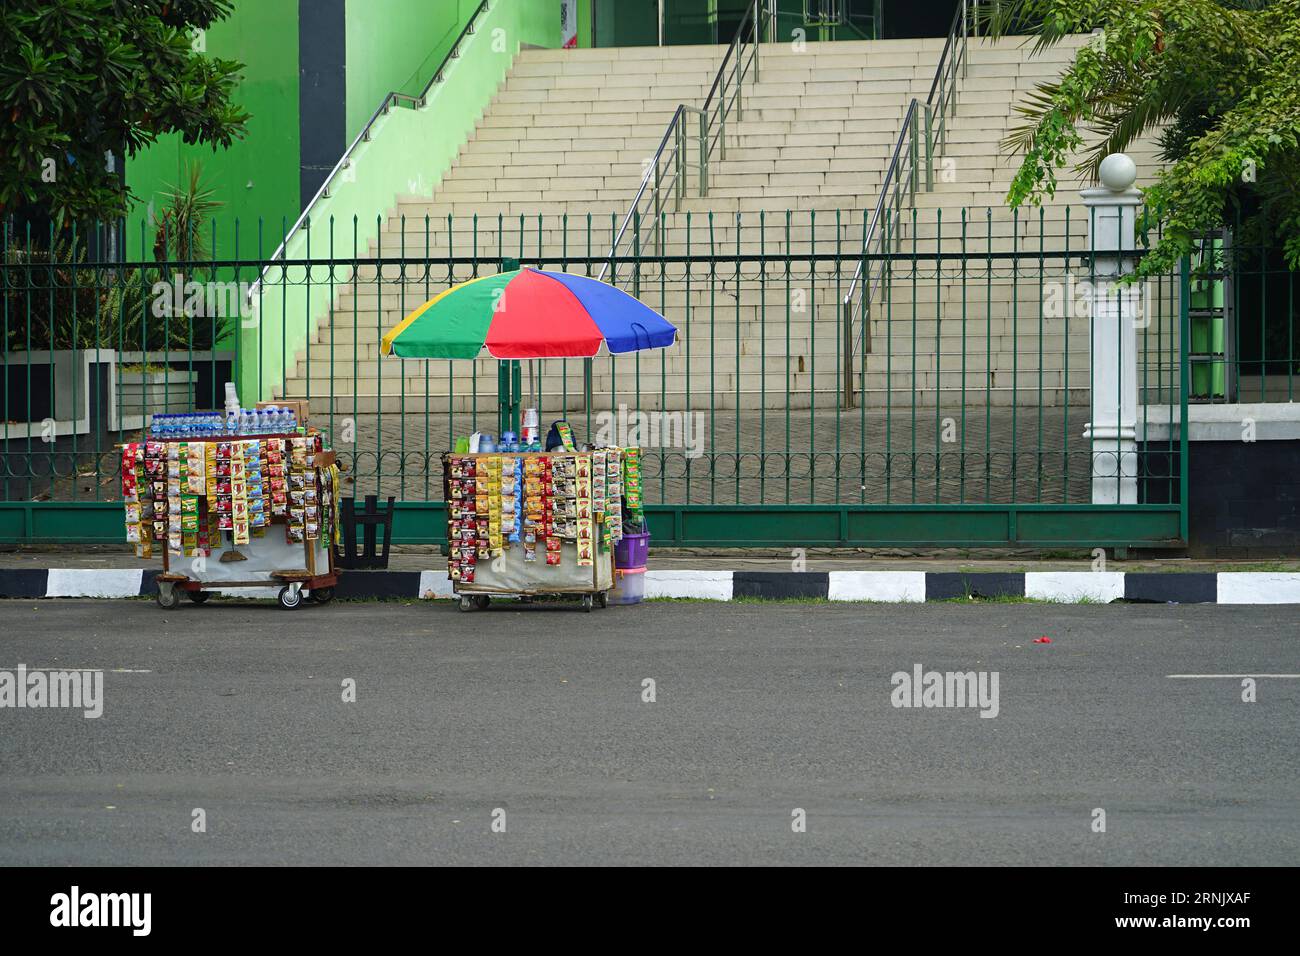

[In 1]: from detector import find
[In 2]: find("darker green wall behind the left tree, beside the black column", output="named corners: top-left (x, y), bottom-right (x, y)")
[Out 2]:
top-left (126, 0), bottom-right (299, 260)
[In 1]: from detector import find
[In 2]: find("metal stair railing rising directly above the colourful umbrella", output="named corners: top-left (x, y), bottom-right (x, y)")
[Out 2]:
top-left (599, 0), bottom-right (764, 282)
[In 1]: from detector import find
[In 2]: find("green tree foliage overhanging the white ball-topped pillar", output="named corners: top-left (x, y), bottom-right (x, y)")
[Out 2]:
top-left (984, 0), bottom-right (1300, 276)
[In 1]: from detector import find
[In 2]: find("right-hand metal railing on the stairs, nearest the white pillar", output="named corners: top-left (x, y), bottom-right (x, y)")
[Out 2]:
top-left (841, 0), bottom-right (978, 408)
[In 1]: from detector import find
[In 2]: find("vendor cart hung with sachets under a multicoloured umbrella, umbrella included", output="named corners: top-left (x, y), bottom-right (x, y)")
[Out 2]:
top-left (381, 260), bottom-right (677, 610)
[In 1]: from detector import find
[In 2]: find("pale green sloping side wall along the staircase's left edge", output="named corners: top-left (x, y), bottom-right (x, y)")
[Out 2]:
top-left (238, 0), bottom-right (560, 405)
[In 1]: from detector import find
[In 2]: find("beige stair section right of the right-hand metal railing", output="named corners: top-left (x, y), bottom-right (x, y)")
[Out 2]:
top-left (857, 36), bottom-right (1177, 407)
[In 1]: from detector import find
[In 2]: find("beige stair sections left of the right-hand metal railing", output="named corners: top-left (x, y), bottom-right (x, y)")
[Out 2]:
top-left (286, 40), bottom-right (943, 412)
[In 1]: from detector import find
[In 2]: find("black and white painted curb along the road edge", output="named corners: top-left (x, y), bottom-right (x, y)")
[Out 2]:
top-left (0, 568), bottom-right (1300, 604)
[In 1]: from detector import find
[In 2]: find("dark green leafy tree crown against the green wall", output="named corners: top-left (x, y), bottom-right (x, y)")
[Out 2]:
top-left (0, 0), bottom-right (248, 222)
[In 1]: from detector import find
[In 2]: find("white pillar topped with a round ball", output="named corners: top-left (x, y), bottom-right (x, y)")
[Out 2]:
top-left (1080, 152), bottom-right (1141, 505)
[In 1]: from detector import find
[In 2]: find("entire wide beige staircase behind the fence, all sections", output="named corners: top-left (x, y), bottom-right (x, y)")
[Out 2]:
top-left (285, 39), bottom-right (1149, 415)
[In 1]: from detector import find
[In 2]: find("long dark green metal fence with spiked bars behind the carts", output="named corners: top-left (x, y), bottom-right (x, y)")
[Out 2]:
top-left (0, 209), bottom-right (1191, 546)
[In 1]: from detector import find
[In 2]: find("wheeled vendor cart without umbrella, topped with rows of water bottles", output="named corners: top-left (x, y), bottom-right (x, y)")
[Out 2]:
top-left (120, 428), bottom-right (338, 609)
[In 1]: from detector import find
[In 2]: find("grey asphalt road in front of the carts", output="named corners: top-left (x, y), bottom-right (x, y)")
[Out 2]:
top-left (0, 601), bottom-right (1300, 865)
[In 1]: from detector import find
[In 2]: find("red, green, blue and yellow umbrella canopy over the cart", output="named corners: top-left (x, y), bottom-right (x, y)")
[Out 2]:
top-left (382, 269), bottom-right (677, 359)
